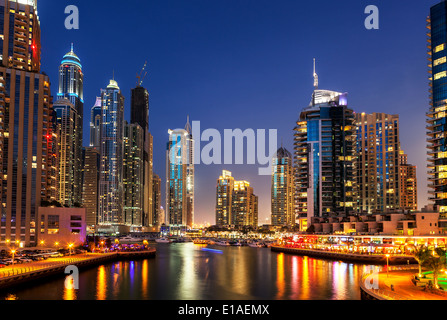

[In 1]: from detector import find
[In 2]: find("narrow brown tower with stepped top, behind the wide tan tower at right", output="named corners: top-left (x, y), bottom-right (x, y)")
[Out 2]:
top-left (399, 150), bottom-right (418, 211)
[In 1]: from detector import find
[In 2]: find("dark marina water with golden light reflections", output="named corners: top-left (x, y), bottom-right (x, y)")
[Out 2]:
top-left (0, 243), bottom-right (374, 300)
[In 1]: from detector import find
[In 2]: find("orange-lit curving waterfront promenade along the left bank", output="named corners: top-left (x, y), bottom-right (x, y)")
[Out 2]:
top-left (0, 249), bottom-right (156, 289)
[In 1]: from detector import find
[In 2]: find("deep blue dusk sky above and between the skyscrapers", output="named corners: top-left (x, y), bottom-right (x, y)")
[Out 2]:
top-left (38, 0), bottom-right (438, 224)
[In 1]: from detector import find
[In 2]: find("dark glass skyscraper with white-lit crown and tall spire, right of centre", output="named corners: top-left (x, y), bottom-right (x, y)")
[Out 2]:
top-left (294, 63), bottom-right (356, 227)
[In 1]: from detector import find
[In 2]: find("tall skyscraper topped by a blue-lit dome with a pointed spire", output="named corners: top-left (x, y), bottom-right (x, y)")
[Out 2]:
top-left (57, 44), bottom-right (84, 206)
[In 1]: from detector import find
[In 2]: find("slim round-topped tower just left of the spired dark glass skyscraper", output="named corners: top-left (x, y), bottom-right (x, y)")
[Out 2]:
top-left (272, 147), bottom-right (296, 226)
